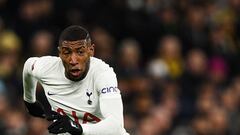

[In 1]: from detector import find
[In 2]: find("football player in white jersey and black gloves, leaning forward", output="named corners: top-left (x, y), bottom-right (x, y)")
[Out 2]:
top-left (23, 25), bottom-right (128, 135)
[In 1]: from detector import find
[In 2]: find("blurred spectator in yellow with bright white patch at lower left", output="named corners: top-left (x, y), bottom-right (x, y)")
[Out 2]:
top-left (148, 36), bottom-right (183, 79)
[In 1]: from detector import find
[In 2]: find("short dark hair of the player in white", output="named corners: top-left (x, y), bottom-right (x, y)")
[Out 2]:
top-left (58, 25), bottom-right (91, 46)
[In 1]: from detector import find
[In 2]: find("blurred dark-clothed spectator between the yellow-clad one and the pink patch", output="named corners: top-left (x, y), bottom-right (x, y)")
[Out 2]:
top-left (179, 49), bottom-right (207, 119)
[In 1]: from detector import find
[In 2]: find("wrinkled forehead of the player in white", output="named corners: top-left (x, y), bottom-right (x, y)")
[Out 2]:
top-left (62, 40), bottom-right (87, 48)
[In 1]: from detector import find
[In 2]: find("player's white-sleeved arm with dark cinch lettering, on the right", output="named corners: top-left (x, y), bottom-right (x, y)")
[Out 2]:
top-left (82, 71), bottom-right (125, 135)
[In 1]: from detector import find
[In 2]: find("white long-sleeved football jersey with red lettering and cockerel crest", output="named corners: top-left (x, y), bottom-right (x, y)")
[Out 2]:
top-left (23, 56), bottom-right (127, 135)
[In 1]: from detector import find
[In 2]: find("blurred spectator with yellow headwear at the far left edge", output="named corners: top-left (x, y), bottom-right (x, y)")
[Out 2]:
top-left (0, 30), bottom-right (21, 104)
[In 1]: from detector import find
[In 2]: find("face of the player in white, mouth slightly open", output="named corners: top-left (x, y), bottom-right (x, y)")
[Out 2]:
top-left (59, 40), bottom-right (94, 81)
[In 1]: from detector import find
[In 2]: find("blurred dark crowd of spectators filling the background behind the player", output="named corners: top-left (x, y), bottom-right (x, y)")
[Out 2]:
top-left (0, 0), bottom-right (240, 135)
